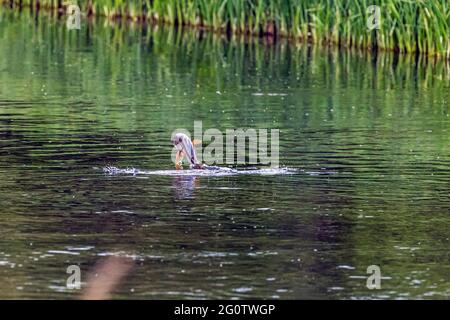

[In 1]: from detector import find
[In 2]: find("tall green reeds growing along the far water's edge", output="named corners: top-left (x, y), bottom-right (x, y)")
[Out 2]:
top-left (4, 0), bottom-right (450, 58)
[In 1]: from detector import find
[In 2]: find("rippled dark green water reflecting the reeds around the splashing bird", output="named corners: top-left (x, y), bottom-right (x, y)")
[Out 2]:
top-left (0, 9), bottom-right (450, 299)
